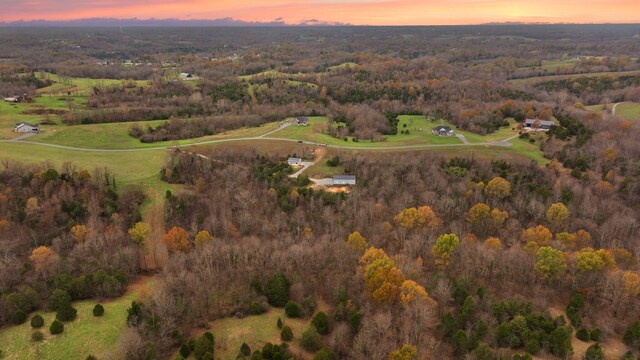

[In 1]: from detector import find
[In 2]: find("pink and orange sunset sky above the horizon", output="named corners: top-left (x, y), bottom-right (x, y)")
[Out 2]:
top-left (0, 0), bottom-right (640, 25)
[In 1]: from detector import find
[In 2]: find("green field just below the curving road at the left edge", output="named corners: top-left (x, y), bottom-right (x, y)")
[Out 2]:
top-left (0, 143), bottom-right (169, 186)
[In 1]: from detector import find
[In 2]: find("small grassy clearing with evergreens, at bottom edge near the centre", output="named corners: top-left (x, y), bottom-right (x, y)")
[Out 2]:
top-left (210, 308), bottom-right (309, 360)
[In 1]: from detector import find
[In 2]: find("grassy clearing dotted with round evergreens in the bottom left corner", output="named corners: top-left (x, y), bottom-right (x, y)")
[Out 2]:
top-left (0, 279), bottom-right (153, 360)
